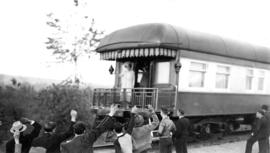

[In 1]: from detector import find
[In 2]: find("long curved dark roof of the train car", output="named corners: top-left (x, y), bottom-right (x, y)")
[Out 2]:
top-left (96, 23), bottom-right (270, 63)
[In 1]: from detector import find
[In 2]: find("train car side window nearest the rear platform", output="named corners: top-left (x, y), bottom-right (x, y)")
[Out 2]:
top-left (189, 62), bottom-right (206, 87)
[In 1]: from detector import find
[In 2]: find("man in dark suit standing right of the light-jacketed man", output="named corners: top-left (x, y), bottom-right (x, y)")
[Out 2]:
top-left (173, 109), bottom-right (190, 153)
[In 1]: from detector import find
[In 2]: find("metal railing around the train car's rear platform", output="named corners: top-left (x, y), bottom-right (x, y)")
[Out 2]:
top-left (92, 88), bottom-right (176, 110)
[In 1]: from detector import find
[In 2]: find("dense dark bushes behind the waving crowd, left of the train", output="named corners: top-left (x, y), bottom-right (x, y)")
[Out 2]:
top-left (0, 84), bottom-right (94, 139)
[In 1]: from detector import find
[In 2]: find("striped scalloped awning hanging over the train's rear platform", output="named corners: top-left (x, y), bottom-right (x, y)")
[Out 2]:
top-left (100, 48), bottom-right (176, 60)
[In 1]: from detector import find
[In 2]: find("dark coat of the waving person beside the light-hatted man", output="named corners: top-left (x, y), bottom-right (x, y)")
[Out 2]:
top-left (32, 122), bottom-right (74, 153)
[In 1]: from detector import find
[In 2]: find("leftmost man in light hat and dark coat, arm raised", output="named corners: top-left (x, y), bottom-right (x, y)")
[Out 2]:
top-left (6, 118), bottom-right (41, 153)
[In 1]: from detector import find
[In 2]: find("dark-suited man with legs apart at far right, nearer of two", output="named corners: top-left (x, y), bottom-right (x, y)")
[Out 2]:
top-left (245, 111), bottom-right (269, 153)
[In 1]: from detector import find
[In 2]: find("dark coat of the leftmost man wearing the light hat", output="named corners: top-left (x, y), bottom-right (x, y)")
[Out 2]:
top-left (6, 122), bottom-right (41, 153)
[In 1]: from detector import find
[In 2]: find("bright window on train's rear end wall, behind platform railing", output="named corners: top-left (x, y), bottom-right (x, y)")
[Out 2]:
top-left (155, 62), bottom-right (170, 84)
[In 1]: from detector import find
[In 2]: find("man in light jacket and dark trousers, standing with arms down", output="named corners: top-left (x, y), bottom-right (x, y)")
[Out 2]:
top-left (158, 107), bottom-right (176, 153)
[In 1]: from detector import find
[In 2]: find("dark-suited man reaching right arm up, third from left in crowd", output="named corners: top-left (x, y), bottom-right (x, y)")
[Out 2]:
top-left (61, 105), bottom-right (118, 153)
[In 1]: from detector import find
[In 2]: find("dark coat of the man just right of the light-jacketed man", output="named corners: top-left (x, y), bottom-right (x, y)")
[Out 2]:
top-left (173, 117), bottom-right (190, 139)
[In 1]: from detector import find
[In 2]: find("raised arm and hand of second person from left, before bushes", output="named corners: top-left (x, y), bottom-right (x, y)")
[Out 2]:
top-left (59, 110), bottom-right (77, 142)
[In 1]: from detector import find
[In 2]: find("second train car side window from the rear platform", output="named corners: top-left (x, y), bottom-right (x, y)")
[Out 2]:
top-left (216, 66), bottom-right (230, 89)
